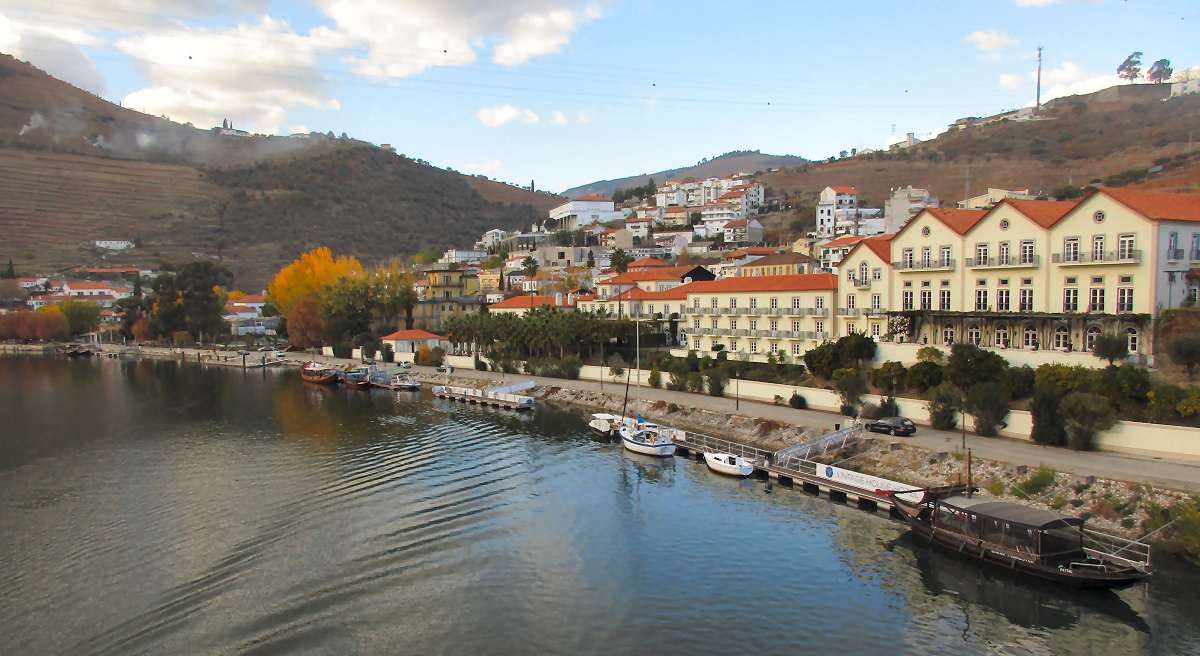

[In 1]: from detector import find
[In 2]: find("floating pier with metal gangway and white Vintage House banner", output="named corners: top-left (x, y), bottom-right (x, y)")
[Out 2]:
top-left (676, 425), bottom-right (911, 514)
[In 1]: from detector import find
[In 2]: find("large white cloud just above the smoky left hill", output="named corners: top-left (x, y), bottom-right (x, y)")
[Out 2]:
top-left (116, 16), bottom-right (340, 133)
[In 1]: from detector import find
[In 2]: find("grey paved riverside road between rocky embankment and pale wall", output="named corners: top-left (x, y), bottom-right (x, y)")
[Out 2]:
top-left (121, 349), bottom-right (1200, 492)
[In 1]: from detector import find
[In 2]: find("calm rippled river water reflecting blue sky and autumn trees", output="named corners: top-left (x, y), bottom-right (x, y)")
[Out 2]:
top-left (0, 356), bottom-right (1200, 655)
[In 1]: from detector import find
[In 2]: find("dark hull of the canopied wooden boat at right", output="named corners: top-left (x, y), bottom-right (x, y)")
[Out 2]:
top-left (893, 498), bottom-right (1150, 590)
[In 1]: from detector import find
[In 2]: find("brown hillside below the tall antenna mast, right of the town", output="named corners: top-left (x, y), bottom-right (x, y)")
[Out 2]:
top-left (758, 85), bottom-right (1200, 211)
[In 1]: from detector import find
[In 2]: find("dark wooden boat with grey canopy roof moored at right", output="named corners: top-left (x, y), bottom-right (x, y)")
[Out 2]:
top-left (892, 485), bottom-right (1150, 589)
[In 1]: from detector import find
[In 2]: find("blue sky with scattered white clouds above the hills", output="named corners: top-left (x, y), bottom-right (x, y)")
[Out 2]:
top-left (0, 0), bottom-right (1200, 192)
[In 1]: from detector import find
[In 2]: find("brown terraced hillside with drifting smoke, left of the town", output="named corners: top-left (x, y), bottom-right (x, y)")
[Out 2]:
top-left (0, 55), bottom-right (562, 289)
